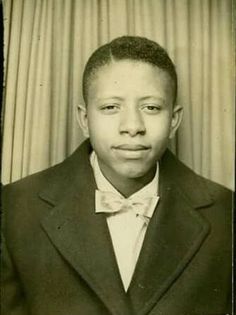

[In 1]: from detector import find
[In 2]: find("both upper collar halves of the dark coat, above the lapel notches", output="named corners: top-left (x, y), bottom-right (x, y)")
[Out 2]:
top-left (40, 140), bottom-right (214, 209)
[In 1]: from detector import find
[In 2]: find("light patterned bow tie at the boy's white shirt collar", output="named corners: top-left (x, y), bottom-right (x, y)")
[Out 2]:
top-left (96, 190), bottom-right (159, 218)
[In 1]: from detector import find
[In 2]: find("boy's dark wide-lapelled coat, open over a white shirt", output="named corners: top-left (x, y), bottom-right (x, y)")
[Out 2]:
top-left (2, 142), bottom-right (232, 315)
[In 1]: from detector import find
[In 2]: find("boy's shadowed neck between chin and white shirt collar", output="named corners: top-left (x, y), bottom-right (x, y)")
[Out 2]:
top-left (97, 165), bottom-right (156, 198)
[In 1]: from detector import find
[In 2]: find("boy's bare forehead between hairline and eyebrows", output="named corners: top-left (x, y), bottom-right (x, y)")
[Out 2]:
top-left (88, 60), bottom-right (174, 99)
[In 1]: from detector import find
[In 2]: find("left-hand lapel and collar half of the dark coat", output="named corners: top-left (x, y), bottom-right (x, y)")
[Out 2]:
top-left (40, 145), bottom-right (134, 315)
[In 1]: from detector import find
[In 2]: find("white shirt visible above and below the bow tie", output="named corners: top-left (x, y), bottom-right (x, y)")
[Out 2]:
top-left (90, 152), bottom-right (159, 291)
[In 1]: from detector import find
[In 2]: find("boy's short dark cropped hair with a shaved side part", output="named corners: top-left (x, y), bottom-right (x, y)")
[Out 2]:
top-left (83, 36), bottom-right (177, 103)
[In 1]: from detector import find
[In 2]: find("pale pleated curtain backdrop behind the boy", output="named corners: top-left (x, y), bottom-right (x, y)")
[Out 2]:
top-left (2, 0), bottom-right (234, 188)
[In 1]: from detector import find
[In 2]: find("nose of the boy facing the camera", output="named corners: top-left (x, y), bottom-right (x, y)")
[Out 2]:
top-left (120, 109), bottom-right (146, 137)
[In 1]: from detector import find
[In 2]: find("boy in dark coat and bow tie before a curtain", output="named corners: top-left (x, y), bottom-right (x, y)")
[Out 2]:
top-left (2, 36), bottom-right (232, 315)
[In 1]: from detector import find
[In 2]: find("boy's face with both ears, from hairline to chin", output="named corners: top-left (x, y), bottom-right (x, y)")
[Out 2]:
top-left (80, 60), bottom-right (182, 184)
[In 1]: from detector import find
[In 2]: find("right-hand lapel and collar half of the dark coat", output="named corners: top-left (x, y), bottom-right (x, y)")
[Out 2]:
top-left (128, 152), bottom-right (212, 315)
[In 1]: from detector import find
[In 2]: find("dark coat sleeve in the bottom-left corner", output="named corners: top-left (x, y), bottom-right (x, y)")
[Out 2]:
top-left (1, 237), bottom-right (29, 315)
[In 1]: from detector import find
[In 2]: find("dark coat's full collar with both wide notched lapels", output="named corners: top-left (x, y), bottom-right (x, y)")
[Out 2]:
top-left (40, 141), bottom-right (213, 315)
